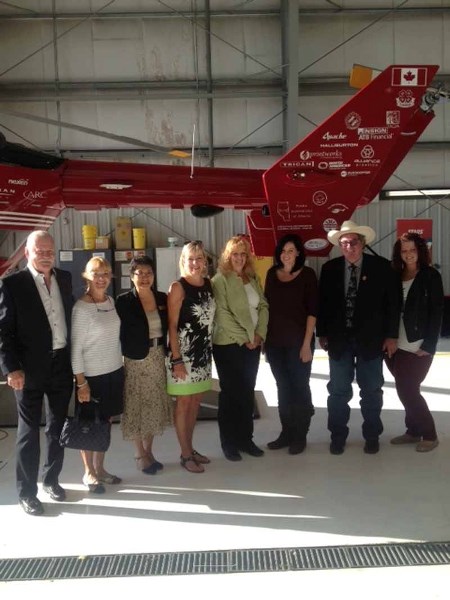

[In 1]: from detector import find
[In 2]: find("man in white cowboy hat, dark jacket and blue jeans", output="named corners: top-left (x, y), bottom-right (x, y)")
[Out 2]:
top-left (317, 221), bottom-right (400, 454)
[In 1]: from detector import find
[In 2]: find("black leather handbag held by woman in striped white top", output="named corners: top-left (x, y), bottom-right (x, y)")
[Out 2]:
top-left (59, 404), bottom-right (111, 452)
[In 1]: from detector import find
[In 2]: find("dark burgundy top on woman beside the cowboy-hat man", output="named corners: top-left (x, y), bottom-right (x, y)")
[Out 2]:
top-left (264, 267), bottom-right (318, 347)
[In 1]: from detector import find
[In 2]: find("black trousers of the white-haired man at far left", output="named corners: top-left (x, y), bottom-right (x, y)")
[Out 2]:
top-left (15, 350), bottom-right (73, 498)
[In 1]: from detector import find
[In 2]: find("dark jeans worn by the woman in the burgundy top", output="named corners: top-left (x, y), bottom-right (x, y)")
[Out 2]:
top-left (266, 346), bottom-right (314, 443)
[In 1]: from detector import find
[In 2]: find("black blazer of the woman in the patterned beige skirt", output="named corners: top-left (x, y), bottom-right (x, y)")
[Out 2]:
top-left (116, 288), bottom-right (167, 360)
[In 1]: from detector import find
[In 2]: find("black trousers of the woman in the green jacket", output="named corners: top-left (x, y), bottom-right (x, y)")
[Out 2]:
top-left (213, 344), bottom-right (261, 449)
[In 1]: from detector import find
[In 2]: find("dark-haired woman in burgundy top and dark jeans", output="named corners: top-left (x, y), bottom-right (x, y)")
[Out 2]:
top-left (265, 234), bottom-right (318, 454)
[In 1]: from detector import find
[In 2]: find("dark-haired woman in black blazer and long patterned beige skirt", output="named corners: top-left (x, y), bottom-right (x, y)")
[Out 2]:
top-left (116, 256), bottom-right (173, 475)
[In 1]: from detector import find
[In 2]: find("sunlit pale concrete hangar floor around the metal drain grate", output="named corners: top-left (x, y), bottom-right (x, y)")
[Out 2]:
top-left (0, 340), bottom-right (450, 600)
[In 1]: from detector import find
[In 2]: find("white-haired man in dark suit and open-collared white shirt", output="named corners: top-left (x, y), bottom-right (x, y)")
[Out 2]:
top-left (0, 231), bottom-right (73, 515)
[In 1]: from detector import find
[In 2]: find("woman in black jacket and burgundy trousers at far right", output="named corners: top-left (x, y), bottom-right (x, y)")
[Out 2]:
top-left (385, 233), bottom-right (444, 452)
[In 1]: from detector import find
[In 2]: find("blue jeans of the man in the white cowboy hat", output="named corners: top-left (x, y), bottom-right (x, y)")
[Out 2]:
top-left (327, 342), bottom-right (384, 444)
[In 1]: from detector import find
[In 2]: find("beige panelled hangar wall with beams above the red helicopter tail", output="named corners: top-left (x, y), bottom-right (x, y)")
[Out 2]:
top-left (0, 0), bottom-right (450, 178)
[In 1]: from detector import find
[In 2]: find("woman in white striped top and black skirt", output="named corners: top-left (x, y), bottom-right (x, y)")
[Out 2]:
top-left (72, 256), bottom-right (124, 494)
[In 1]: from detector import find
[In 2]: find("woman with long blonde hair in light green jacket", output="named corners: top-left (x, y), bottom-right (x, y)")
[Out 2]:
top-left (212, 236), bottom-right (269, 461)
